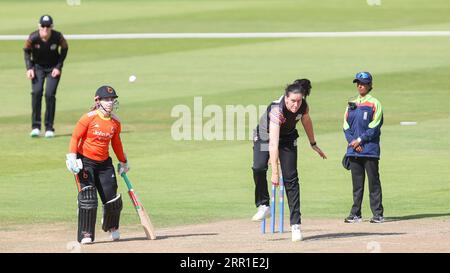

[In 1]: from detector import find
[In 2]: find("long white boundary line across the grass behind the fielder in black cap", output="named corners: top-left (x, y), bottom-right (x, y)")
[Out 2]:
top-left (0, 31), bottom-right (450, 41)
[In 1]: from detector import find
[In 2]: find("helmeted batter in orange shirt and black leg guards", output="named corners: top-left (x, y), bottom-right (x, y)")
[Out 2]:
top-left (66, 86), bottom-right (129, 244)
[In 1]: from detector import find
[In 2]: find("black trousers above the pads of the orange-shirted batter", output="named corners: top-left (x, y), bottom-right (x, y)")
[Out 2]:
top-left (78, 154), bottom-right (117, 204)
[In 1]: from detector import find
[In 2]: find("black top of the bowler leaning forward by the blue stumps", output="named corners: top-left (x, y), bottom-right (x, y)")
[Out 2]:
top-left (253, 96), bottom-right (308, 142)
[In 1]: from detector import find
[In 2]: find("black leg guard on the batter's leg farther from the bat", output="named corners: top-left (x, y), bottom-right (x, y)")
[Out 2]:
top-left (78, 186), bottom-right (98, 242)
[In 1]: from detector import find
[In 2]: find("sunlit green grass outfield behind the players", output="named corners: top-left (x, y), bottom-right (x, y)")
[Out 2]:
top-left (0, 0), bottom-right (450, 227)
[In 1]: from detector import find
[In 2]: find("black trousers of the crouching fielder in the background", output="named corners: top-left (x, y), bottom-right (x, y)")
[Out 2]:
top-left (31, 65), bottom-right (60, 131)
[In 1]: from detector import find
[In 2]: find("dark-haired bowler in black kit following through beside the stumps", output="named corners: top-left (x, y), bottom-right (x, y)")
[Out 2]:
top-left (252, 79), bottom-right (327, 242)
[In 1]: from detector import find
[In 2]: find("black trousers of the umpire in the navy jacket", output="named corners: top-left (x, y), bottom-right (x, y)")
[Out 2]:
top-left (350, 157), bottom-right (384, 216)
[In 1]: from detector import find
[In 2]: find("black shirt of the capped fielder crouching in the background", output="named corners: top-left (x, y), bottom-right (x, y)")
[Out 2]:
top-left (23, 30), bottom-right (69, 70)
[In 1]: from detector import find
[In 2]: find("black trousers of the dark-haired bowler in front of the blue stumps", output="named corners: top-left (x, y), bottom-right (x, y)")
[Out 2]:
top-left (252, 140), bottom-right (301, 225)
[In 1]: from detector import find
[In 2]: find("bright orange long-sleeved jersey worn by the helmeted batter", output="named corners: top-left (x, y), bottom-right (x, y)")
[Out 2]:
top-left (70, 110), bottom-right (126, 162)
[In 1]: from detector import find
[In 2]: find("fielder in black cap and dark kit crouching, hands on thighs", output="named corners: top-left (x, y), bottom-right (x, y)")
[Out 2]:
top-left (24, 15), bottom-right (68, 137)
